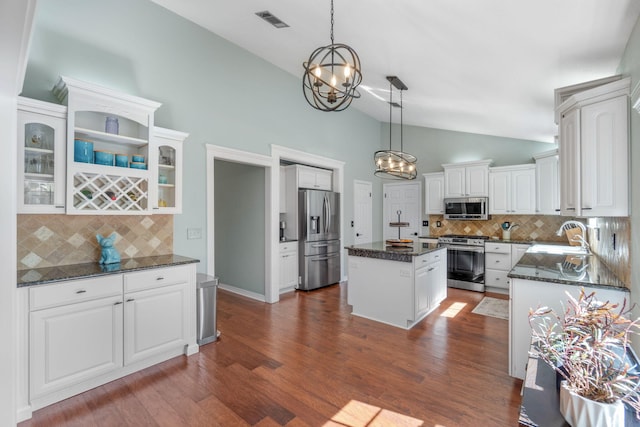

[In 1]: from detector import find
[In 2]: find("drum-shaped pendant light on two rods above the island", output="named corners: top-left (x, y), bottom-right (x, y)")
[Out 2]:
top-left (373, 76), bottom-right (418, 179)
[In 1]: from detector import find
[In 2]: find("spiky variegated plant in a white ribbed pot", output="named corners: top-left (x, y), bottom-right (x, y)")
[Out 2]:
top-left (529, 289), bottom-right (640, 426)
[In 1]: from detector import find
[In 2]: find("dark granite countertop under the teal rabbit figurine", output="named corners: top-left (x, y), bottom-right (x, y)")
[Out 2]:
top-left (17, 254), bottom-right (200, 288)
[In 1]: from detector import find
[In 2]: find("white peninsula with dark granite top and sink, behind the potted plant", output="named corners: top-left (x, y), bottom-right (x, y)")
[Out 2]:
top-left (508, 249), bottom-right (630, 379)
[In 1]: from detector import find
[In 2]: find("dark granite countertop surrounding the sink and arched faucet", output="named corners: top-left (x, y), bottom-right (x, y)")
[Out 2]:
top-left (508, 252), bottom-right (626, 289)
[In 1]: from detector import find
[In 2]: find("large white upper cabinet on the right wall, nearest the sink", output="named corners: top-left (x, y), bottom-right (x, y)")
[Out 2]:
top-left (556, 78), bottom-right (630, 216)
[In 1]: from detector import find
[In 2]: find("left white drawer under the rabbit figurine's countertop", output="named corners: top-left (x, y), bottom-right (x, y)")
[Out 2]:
top-left (29, 274), bottom-right (122, 311)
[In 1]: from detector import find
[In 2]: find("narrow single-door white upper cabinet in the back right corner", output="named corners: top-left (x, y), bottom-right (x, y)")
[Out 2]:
top-left (534, 150), bottom-right (560, 215)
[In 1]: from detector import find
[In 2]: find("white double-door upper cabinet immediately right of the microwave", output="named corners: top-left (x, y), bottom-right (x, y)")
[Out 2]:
top-left (489, 164), bottom-right (536, 215)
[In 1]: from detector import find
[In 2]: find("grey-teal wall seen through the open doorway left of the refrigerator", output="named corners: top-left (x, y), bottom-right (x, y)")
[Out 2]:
top-left (214, 160), bottom-right (265, 295)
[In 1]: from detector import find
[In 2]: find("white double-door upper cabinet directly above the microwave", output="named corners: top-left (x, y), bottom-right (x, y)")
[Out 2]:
top-left (442, 160), bottom-right (493, 198)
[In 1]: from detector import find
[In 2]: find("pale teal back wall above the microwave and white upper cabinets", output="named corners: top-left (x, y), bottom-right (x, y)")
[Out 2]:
top-left (380, 123), bottom-right (557, 176)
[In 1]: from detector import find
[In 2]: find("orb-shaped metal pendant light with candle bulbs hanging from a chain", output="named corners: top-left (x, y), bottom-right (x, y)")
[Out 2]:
top-left (302, 0), bottom-right (362, 111)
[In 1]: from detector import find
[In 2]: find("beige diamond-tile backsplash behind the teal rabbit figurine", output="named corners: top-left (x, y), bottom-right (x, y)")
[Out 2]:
top-left (18, 215), bottom-right (173, 270)
